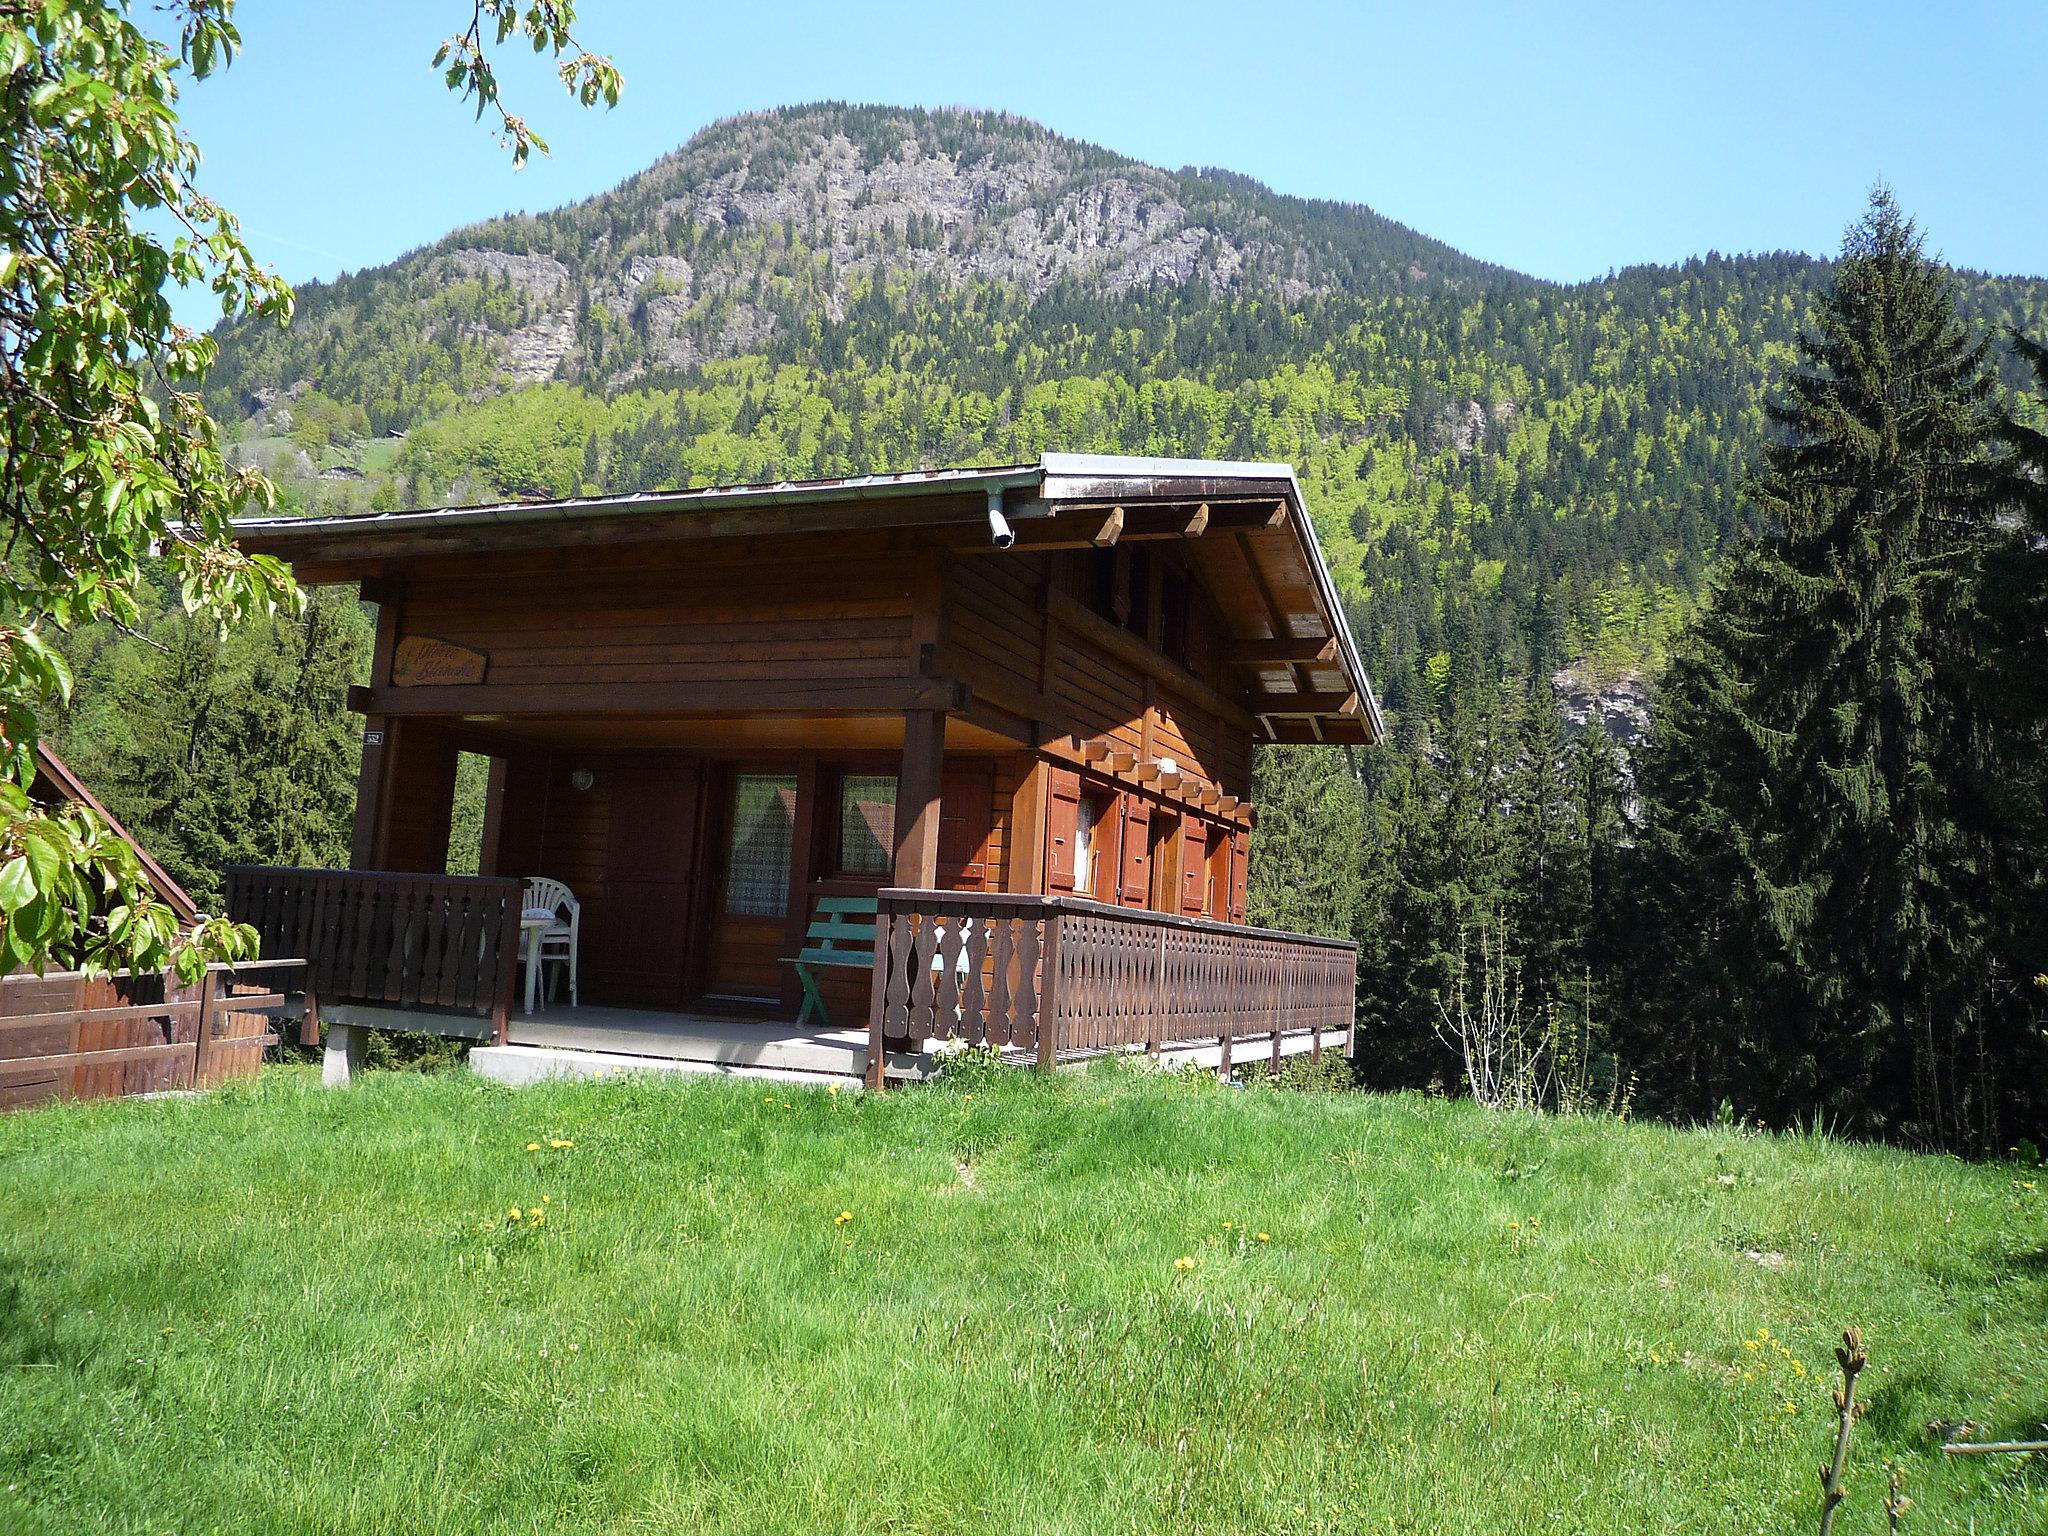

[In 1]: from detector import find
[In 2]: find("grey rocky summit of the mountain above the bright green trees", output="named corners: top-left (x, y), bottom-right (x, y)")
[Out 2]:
top-left (217, 104), bottom-right (1520, 409)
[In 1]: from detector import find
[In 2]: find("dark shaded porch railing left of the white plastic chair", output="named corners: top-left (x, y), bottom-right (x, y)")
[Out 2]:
top-left (223, 864), bottom-right (524, 1040)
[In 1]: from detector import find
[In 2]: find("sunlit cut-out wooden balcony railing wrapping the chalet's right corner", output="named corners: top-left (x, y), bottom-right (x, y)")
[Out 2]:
top-left (868, 889), bottom-right (1358, 1085)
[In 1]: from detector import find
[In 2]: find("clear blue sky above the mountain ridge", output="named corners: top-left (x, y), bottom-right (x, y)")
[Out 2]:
top-left (167, 0), bottom-right (2048, 324)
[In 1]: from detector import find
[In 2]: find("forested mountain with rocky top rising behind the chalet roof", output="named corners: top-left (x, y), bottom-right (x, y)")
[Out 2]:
top-left (195, 104), bottom-right (2048, 741)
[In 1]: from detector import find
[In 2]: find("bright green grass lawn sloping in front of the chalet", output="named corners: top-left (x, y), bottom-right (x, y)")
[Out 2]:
top-left (0, 1069), bottom-right (2048, 1536)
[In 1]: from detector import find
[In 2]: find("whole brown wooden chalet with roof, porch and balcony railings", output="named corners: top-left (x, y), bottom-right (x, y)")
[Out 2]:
top-left (229, 455), bottom-right (1380, 1081)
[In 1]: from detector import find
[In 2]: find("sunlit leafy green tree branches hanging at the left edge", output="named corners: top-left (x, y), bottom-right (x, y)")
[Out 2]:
top-left (0, 0), bottom-right (621, 977)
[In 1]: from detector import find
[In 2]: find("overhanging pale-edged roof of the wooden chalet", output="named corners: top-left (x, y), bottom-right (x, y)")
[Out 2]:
top-left (236, 453), bottom-right (1384, 739)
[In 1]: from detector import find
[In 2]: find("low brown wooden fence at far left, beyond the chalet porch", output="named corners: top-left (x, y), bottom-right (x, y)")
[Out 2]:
top-left (0, 961), bottom-right (305, 1110)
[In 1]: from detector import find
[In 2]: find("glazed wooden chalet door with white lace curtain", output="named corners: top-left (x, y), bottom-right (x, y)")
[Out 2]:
top-left (705, 768), bottom-right (799, 1004)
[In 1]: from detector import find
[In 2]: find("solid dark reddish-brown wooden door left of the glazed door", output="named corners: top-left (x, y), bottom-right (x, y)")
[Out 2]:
top-left (582, 756), bottom-right (705, 1008)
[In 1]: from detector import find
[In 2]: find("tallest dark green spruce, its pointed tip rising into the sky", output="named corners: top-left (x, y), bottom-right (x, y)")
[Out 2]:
top-left (1653, 190), bottom-right (2001, 1145)
